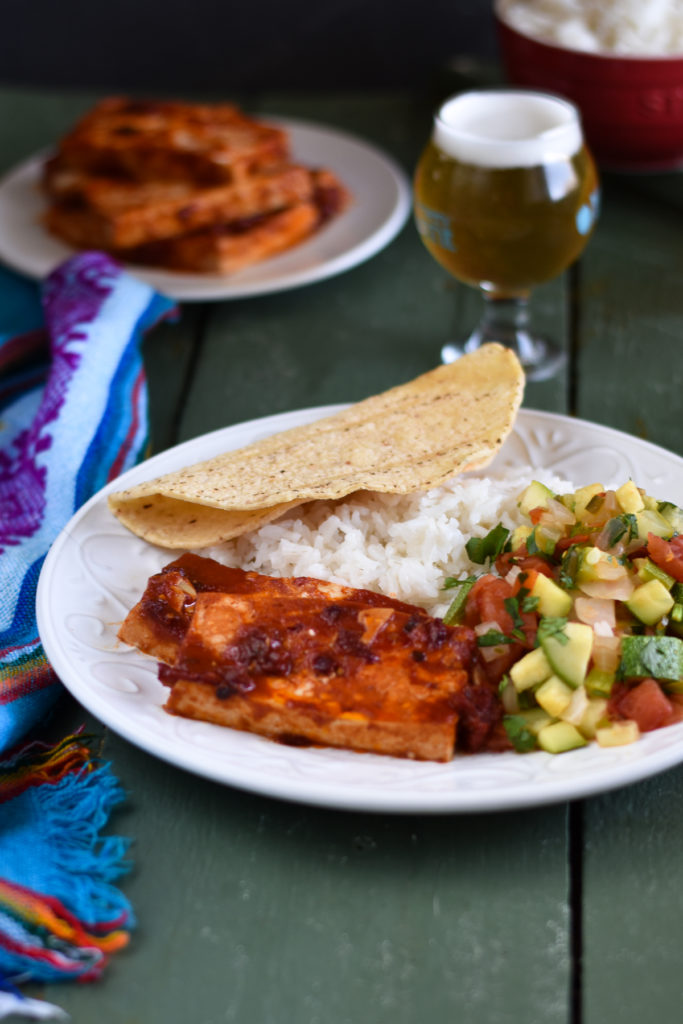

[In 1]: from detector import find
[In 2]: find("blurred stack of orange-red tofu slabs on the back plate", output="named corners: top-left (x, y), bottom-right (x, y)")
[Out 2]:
top-left (43, 97), bottom-right (350, 274)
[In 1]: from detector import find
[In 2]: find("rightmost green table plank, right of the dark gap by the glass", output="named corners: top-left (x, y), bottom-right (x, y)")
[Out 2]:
top-left (578, 163), bottom-right (683, 1024)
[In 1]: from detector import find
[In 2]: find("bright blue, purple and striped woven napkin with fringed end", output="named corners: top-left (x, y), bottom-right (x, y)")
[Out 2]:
top-left (0, 252), bottom-right (173, 1017)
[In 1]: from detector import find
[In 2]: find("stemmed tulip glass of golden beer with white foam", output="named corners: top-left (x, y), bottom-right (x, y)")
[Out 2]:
top-left (415, 89), bottom-right (599, 380)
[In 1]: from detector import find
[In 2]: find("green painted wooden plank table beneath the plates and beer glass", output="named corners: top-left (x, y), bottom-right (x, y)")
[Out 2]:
top-left (5, 89), bottom-right (683, 1024)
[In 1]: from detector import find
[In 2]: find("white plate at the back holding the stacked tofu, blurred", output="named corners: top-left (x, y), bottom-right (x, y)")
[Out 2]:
top-left (0, 118), bottom-right (412, 301)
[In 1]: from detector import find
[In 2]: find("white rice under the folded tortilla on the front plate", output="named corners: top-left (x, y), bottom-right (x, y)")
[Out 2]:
top-left (201, 468), bottom-right (574, 615)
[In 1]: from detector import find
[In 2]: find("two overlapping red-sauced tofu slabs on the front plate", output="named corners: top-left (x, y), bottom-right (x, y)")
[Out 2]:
top-left (120, 555), bottom-right (495, 761)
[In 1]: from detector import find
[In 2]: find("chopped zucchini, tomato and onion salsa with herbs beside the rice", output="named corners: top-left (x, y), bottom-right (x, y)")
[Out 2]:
top-left (444, 480), bottom-right (683, 754)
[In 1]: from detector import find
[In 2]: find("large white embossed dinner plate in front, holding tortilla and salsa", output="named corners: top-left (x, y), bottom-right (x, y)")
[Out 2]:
top-left (37, 407), bottom-right (683, 813)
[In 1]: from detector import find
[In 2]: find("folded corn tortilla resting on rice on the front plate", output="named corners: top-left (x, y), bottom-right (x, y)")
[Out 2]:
top-left (109, 344), bottom-right (524, 550)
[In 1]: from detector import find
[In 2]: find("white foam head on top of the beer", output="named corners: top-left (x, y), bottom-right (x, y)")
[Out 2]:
top-left (432, 89), bottom-right (583, 168)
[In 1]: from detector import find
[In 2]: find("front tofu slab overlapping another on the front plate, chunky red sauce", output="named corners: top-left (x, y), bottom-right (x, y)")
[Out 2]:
top-left (160, 592), bottom-right (474, 761)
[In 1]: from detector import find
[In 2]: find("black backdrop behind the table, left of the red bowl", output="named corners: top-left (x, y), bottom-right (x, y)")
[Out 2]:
top-left (0, 0), bottom-right (497, 95)
